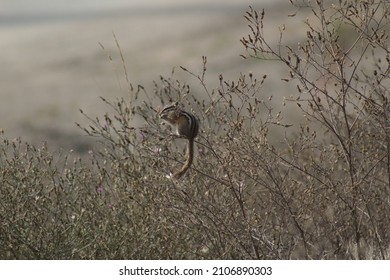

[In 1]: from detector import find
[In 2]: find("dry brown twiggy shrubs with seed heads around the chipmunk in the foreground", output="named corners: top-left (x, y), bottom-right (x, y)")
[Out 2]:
top-left (0, 1), bottom-right (390, 259)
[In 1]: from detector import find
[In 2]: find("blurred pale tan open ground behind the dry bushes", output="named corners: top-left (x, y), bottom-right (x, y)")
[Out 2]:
top-left (0, 0), bottom-right (304, 154)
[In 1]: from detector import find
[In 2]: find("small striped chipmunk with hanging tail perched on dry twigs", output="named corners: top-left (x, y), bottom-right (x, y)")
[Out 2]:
top-left (160, 102), bottom-right (199, 179)
